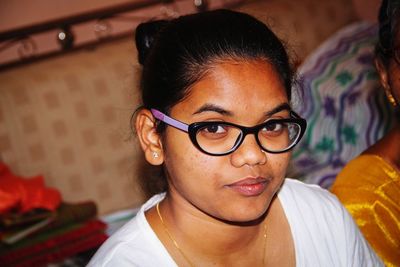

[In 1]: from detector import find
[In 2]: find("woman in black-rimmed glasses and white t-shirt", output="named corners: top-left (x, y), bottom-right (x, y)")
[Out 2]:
top-left (89, 10), bottom-right (381, 266)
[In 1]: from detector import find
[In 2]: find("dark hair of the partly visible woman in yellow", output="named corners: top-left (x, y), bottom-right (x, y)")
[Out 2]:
top-left (375, 0), bottom-right (400, 65)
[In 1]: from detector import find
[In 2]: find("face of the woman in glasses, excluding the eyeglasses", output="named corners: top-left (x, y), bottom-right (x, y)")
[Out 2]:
top-left (163, 60), bottom-right (290, 222)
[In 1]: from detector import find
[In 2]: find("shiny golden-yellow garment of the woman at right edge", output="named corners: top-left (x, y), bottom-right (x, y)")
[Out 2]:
top-left (331, 155), bottom-right (400, 266)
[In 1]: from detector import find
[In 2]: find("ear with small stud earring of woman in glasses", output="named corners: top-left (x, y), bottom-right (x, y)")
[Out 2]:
top-left (135, 109), bottom-right (164, 165)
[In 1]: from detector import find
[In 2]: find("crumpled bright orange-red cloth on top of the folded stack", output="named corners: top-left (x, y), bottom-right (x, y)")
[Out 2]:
top-left (0, 162), bottom-right (61, 214)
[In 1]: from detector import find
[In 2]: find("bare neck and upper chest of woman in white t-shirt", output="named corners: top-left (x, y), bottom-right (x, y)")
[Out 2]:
top-left (150, 196), bottom-right (267, 266)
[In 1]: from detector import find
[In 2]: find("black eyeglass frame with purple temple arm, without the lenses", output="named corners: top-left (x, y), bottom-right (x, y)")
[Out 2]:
top-left (151, 109), bottom-right (307, 156)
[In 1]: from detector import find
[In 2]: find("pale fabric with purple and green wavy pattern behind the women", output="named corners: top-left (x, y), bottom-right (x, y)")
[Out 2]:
top-left (289, 22), bottom-right (393, 188)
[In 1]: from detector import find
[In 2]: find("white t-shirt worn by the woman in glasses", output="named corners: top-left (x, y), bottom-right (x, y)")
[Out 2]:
top-left (88, 179), bottom-right (383, 267)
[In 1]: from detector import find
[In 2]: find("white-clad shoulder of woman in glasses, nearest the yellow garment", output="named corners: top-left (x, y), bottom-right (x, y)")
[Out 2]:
top-left (278, 179), bottom-right (381, 266)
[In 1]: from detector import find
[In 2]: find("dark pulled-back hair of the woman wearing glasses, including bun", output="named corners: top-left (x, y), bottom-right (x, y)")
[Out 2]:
top-left (135, 10), bottom-right (293, 196)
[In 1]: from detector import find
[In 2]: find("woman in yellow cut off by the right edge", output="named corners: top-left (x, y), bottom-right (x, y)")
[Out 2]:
top-left (331, 0), bottom-right (400, 266)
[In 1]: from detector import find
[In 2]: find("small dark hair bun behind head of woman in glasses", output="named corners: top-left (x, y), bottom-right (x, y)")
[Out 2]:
top-left (135, 20), bottom-right (168, 65)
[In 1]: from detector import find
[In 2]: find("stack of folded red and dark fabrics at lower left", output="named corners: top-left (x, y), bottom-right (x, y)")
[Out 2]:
top-left (0, 163), bottom-right (108, 267)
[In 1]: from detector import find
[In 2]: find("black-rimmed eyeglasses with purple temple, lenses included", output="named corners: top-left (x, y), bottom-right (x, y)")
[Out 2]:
top-left (151, 109), bottom-right (307, 156)
